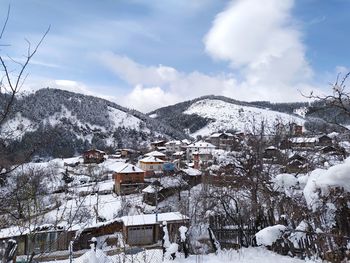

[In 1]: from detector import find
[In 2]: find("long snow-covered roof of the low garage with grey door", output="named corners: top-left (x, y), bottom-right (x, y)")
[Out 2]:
top-left (121, 212), bottom-right (189, 226)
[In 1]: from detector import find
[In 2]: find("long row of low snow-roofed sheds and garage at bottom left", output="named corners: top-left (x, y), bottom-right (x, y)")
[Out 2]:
top-left (0, 212), bottom-right (189, 261)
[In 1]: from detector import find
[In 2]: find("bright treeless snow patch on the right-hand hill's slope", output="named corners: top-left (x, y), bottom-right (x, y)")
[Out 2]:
top-left (184, 99), bottom-right (304, 137)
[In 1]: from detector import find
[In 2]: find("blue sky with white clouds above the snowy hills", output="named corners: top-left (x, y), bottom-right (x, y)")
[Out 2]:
top-left (0, 0), bottom-right (350, 112)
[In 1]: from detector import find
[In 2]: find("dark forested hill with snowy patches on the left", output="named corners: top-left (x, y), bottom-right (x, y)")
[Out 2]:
top-left (1, 89), bottom-right (184, 157)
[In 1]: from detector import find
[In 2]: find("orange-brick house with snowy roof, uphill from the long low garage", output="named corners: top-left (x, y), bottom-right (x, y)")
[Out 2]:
top-left (113, 164), bottom-right (145, 195)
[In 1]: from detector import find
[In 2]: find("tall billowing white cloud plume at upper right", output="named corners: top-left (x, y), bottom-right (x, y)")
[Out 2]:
top-left (204, 0), bottom-right (312, 88)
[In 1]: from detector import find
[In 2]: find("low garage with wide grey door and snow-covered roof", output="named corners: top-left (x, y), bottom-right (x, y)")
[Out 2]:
top-left (121, 212), bottom-right (189, 246)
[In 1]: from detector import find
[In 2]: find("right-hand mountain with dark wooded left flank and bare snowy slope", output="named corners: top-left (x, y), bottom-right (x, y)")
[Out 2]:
top-left (149, 96), bottom-right (305, 136)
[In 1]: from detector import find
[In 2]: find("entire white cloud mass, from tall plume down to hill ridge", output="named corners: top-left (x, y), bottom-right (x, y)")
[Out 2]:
top-left (92, 0), bottom-right (315, 111)
